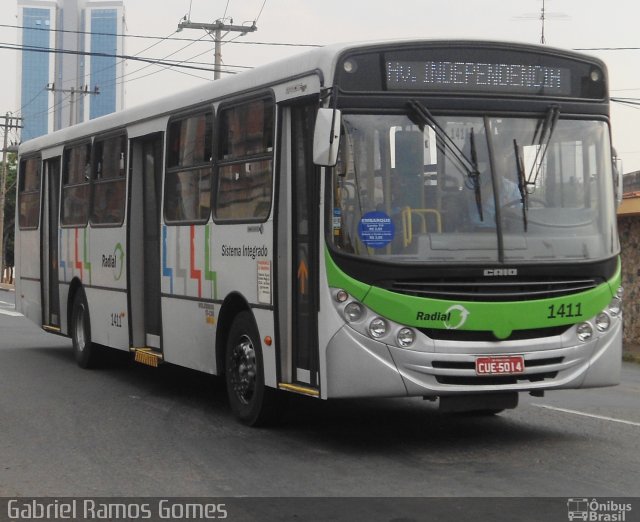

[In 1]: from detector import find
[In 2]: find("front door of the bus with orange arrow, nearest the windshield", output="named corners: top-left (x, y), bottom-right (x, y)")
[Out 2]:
top-left (278, 98), bottom-right (320, 390)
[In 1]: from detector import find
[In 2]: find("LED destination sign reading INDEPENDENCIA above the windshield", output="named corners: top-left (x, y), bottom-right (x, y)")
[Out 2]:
top-left (385, 60), bottom-right (571, 96)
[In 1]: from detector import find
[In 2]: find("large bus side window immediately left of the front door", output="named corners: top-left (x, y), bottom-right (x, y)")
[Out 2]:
top-left (214, 100), bottom-right (274, 221)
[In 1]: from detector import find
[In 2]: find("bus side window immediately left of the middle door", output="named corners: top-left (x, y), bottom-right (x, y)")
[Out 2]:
top-left (91, 135), bottom-right (127, 225)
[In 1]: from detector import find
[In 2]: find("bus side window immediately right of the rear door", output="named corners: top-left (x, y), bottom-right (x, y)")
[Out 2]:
top-left (61, 143), bottom-right (91, 226)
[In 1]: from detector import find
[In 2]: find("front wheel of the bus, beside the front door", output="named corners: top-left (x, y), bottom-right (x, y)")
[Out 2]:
top-left (225, 311), bottom-right (277, 426)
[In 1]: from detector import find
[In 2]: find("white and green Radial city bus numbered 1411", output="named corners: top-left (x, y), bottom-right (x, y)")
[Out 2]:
top-left (15, 40), bottom-right (622, 425)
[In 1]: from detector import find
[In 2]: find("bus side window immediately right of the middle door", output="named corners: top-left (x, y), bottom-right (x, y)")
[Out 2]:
top-left (164, 112), bottom-right (213, 223)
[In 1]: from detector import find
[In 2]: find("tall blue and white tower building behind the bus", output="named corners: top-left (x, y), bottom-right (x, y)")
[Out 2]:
top-left (17, 0), bottom-right (124, 141)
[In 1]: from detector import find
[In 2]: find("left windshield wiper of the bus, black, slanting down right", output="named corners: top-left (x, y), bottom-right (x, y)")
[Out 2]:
top-left (407, 100), bottom-right (484, 221)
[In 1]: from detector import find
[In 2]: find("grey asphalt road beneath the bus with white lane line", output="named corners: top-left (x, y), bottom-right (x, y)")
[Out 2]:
top-left (0, 292), bottom-right (640, 497)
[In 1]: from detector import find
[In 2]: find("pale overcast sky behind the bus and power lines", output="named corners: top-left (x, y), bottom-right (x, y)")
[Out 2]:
top-left (0, 0), bottom-right (640, 172)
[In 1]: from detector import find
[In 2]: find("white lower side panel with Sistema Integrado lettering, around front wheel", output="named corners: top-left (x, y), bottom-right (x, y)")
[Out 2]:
top-left (161, 222), bottom-right (276, 378)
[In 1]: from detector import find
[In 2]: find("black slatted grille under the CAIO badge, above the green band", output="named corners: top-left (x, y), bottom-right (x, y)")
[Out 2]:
top-left (387, 278), bottom-right (602, 301)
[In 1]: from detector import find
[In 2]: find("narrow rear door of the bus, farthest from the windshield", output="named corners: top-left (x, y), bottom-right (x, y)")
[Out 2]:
top-left (40, 157), bottom-right (60, 332)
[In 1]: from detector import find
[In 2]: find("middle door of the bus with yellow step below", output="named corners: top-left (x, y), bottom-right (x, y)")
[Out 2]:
top-left (127, 132), bottom-right (164, 358)
